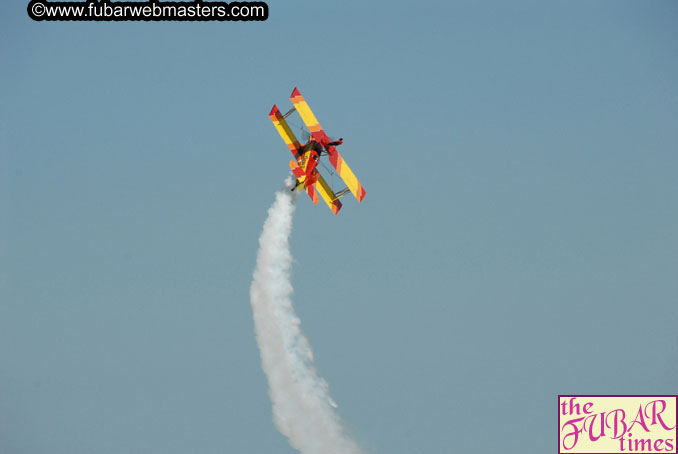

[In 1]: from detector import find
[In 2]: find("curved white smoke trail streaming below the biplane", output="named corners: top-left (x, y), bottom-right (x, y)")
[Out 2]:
top-left (250, 182), bottom-right (362, 454)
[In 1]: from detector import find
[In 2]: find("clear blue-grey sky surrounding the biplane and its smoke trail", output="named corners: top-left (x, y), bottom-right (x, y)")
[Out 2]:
top-left (0, 1), bottom-right (678, 454)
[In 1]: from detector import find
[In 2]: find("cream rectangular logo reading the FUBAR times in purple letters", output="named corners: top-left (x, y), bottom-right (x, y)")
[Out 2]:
top-left (558, 395), bottom-right (678, 454)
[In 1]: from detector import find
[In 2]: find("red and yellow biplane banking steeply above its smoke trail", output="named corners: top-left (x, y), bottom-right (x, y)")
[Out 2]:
top-left (269, 88), bottom-right (365, 214)
